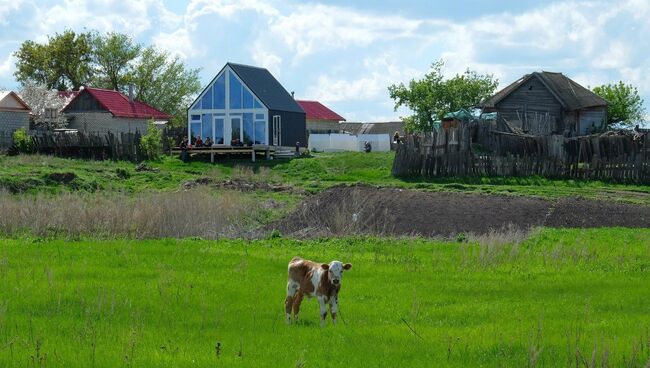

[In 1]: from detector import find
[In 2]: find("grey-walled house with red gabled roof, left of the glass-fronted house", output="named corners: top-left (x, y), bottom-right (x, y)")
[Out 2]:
top-left (62, 87), bottom-right (171, 134)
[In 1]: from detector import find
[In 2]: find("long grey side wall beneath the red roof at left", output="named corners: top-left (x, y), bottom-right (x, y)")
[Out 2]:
top-left (66, 112), bottom-right (149, 134)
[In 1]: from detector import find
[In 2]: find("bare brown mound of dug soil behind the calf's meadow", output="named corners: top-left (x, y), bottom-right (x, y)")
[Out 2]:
top-left (268, 185), bottom-right (650, 237)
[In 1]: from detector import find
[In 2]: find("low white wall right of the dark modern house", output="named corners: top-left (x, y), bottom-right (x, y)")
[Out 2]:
top-left (309, 134), bottom-right (390, 152)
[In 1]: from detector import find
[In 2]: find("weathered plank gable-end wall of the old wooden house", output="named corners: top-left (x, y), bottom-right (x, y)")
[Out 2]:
top-left (496, 77), bottom-right (564, 133)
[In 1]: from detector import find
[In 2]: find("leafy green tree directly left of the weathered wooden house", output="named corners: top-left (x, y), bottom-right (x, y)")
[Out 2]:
top-left (388, 60), bottom-right (499, 131)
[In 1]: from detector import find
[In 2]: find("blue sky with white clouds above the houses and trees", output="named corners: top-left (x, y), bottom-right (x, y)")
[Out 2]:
top-left (0, 0), bottom-right (650, 121)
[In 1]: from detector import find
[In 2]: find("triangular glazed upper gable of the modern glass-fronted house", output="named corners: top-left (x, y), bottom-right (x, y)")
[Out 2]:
top-left (190, 64), bottom-right (268, 110)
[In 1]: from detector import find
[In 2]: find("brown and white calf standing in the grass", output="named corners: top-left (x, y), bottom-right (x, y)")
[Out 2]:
top-left (284, 257), bottom-right (352, 326)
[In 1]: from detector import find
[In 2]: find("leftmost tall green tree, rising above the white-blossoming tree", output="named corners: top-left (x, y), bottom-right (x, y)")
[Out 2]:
top-left (14, 30), bottom-right (92, 90)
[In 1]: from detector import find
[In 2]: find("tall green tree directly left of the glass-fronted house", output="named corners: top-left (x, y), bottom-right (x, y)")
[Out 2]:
top-left (133, 46), bottom-right (201, 124)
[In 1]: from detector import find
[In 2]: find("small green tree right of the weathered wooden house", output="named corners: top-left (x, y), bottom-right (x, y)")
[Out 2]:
top-left (593, 81), bottom-right (645, 127)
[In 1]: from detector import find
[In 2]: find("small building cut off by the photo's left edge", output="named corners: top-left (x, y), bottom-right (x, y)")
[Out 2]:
top-left (0, 91), bottom-right (31, 148)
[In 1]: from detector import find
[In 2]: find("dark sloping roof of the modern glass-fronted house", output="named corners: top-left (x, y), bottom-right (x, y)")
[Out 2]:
top-left (227, 63), bottom-right (305, 113)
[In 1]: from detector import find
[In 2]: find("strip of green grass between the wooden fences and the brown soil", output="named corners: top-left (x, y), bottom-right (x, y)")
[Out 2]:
top-left (0, 152), bottom-right (650, 205)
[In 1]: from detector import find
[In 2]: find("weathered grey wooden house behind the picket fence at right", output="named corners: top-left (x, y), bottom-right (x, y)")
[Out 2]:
top-left (482, 72), bottom-right (607, 136)
